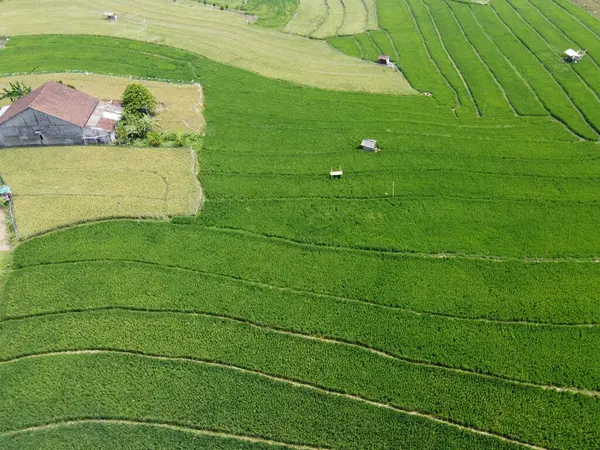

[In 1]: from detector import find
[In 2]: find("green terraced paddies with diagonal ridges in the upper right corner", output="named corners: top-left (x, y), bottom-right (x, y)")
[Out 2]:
top-left (329, 0), bottom-right (600, 140)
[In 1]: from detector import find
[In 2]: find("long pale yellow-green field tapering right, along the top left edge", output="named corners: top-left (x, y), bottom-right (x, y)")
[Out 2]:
top-left (0, 0), bottom-right (415, 94)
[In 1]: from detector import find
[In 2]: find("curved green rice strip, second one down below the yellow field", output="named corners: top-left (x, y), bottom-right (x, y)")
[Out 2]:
top-left (6, 262), bottom-right (600, 390)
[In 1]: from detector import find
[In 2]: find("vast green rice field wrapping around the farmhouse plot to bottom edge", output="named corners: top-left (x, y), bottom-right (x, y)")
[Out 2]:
top-left (0, 34), bottom-right (600, 450)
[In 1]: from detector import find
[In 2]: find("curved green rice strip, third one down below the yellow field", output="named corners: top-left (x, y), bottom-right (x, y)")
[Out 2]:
top-left (0, 310), bottom-right (600, 449)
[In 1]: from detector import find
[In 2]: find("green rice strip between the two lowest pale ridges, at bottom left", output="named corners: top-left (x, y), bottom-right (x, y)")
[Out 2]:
top-left (0, 354), bottom-right (518, 449)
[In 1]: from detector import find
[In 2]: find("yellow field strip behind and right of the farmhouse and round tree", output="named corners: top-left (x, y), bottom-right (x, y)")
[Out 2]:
top-left (0, 73), bottom-right (205, 132)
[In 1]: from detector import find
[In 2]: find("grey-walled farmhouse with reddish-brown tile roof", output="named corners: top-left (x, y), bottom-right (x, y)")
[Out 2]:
top-left (0, 81), bottom-right (123, 147)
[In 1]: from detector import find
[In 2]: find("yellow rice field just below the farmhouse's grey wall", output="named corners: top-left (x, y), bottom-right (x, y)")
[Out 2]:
top-left (0, 146), bottom-right (202, 239)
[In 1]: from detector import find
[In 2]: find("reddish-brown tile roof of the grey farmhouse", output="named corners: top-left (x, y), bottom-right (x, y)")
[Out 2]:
top-left (0, 81), bottom-right (98, 128)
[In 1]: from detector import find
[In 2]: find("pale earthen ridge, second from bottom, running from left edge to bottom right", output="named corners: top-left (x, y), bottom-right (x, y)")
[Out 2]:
top-left (0, 349), bottom-right (547, 450)
